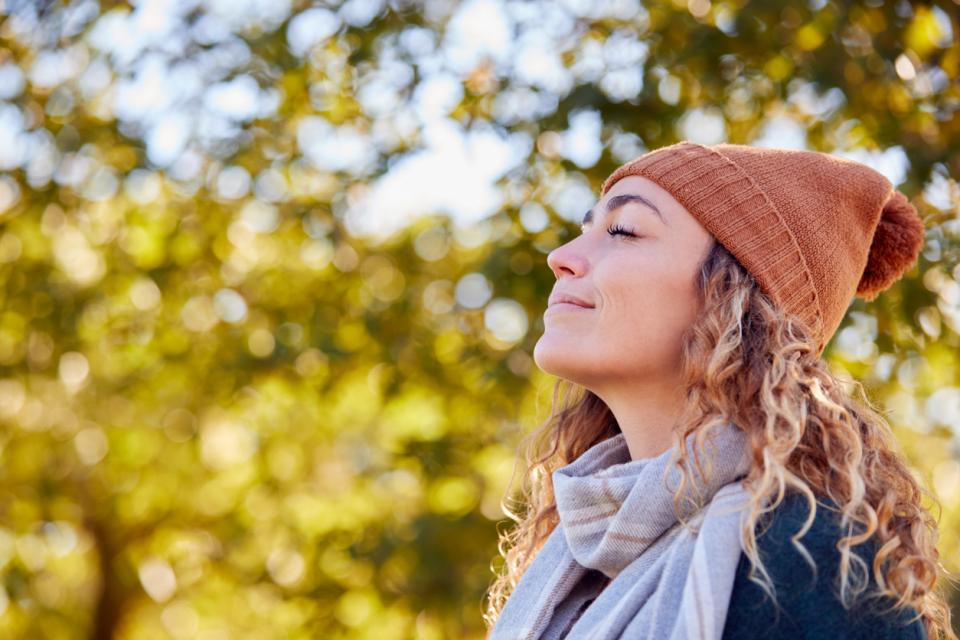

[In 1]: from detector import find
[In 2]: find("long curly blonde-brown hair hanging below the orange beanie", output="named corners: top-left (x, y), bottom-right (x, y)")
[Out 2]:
top-left (483, 242), bottom-right (957, 640)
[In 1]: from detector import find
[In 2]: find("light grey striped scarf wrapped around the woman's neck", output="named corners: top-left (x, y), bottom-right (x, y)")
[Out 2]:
top-left (489, 422), bottom-right (751, 640)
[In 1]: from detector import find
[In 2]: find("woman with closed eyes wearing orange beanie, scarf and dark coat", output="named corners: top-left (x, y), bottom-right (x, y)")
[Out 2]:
top-left (485, 141), bottom-right (956, 640)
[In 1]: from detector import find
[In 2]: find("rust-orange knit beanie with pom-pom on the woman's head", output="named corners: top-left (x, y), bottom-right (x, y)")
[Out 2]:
top-left (601, 140), bottom-right (924, 355)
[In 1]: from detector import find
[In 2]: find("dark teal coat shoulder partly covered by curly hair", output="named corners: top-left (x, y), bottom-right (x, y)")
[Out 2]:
top-left (723, 493), bottom-right (926, 640)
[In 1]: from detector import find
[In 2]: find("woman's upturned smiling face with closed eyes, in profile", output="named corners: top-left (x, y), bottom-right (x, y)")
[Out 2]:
top-left (533, 176), bottom-right (714, 396)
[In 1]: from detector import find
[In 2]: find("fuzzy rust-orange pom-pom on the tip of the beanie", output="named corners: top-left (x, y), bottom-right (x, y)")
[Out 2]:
top-left (856, 190), bottom-right (924, 300)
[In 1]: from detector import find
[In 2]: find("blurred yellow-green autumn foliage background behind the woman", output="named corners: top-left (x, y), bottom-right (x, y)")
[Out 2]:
top-left (0, 0), bottom-right (960, 640)
